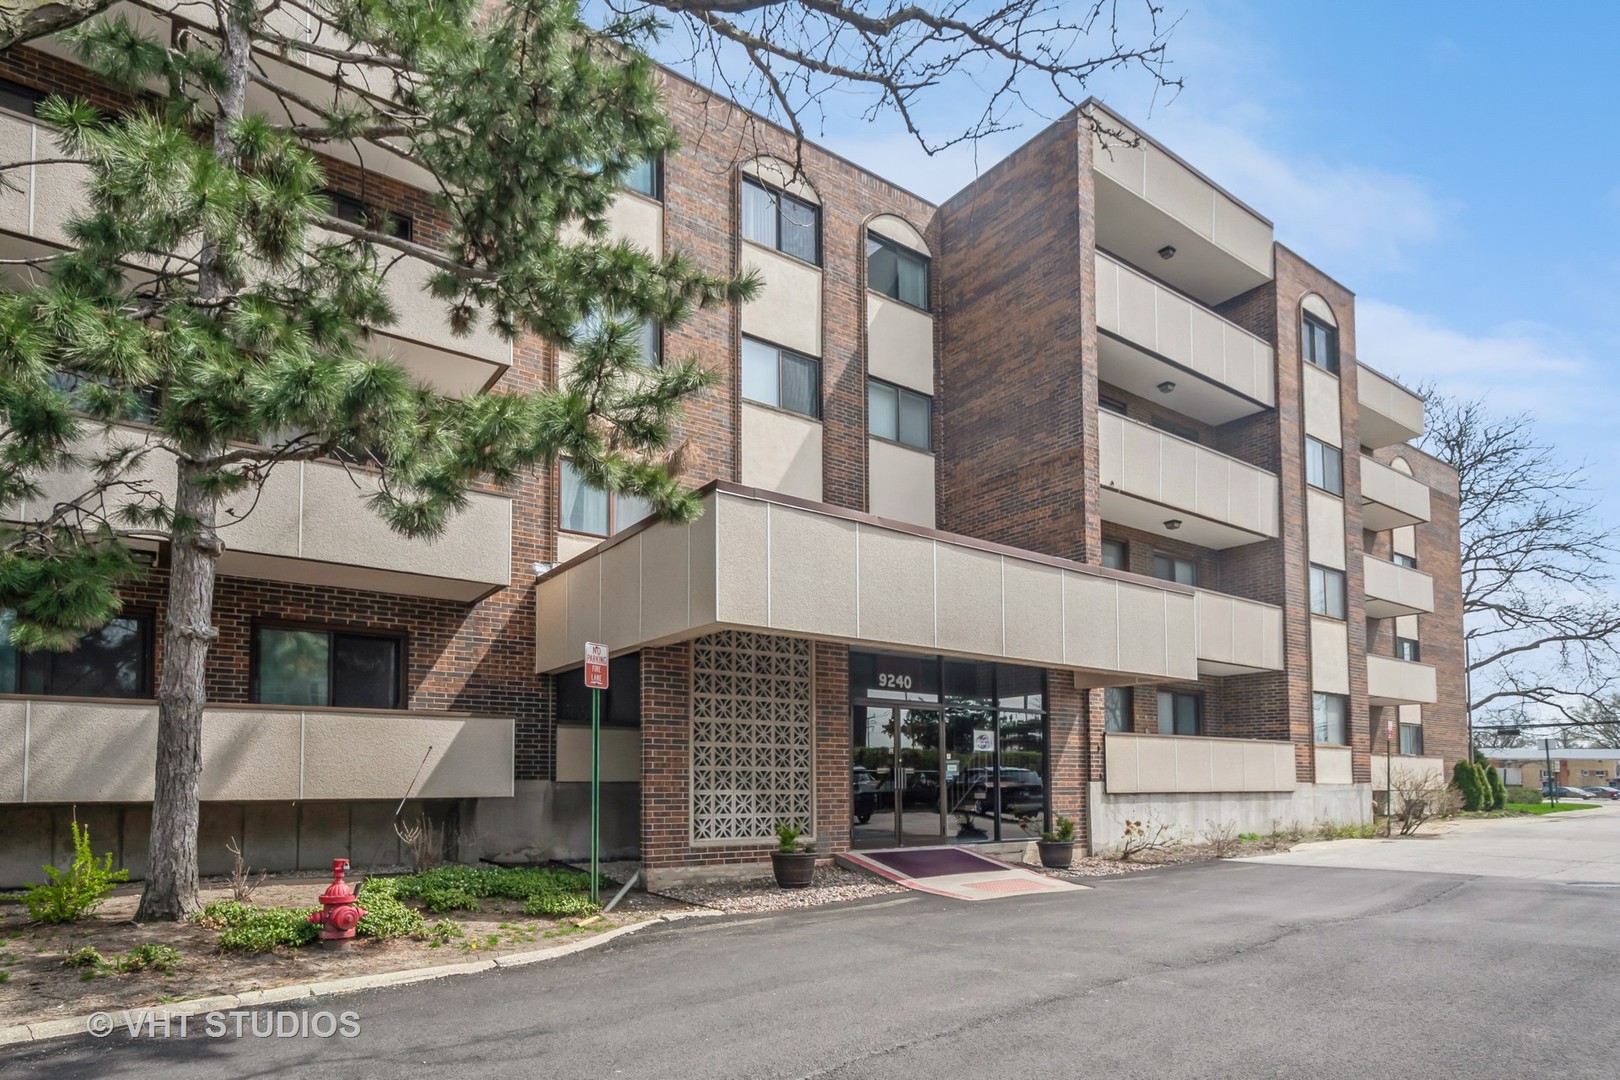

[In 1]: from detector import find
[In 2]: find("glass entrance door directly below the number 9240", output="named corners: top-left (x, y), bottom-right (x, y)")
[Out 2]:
top-left (851, 704), bottom-right (948, 847)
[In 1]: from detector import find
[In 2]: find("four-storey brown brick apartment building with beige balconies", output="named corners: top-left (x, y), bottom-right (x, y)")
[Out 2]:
top-left (0, 13), bottom-right (1466, 884)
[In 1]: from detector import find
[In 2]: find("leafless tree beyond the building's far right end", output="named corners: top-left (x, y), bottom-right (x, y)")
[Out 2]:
top-left (1422, 390), bottom-right (1620, 727)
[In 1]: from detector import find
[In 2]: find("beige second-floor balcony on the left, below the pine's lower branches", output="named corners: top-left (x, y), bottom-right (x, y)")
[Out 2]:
top-left (6, 427), bottom-right (512, 601)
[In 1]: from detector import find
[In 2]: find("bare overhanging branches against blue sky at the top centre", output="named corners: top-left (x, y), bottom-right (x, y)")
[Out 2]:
top-left (0, 0), bottom-right (1181, 154)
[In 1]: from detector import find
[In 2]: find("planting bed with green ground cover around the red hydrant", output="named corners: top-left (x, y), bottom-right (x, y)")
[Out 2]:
top-left (0, 866), bottom-right (690, 1028)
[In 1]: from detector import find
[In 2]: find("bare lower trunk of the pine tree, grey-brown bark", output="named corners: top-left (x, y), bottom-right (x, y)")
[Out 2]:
top-left (134, 460), bottom-right (224, 923)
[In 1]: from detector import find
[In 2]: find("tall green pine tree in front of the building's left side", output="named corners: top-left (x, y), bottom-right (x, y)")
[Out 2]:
top-left (0, 0), bottom-right (755, 920)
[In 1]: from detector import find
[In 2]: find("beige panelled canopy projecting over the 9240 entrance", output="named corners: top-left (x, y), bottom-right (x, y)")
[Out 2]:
top-left (535, 481), bottom-right (1199, 687)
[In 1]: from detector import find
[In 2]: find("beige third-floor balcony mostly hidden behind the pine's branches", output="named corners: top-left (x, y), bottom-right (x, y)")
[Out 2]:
top-left (0, 112), bottom-right (512, 397)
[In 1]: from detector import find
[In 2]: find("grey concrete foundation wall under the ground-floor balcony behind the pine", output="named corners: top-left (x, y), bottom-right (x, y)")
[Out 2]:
top-left (0, 800), bottom-right (473, 902)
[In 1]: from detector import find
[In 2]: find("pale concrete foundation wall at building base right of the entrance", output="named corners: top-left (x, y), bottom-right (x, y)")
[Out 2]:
top-left (1087, 782), bottom-right (1372, 855)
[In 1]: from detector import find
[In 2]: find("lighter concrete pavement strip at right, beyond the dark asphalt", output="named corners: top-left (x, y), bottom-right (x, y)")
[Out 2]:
top-left (1238, 803), bottom-right (1620, 886)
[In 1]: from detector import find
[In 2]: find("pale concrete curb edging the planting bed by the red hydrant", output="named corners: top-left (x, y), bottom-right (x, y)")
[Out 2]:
top-left (0, 912), bottom-right (690, 1046)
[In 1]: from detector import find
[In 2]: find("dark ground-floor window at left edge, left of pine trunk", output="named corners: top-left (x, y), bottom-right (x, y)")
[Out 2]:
top-left (0, 610), bottom-right (152, 698)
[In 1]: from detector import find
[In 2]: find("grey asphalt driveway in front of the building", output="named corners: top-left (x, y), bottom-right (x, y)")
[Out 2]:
top-left (0, 811), bottom-right (1620, 1080)
